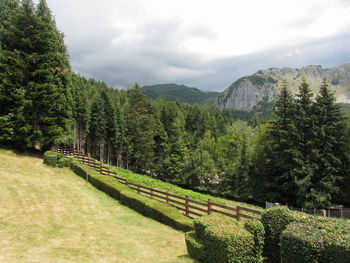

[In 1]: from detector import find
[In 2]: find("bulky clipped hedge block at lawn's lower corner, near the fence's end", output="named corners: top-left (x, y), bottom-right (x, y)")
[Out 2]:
top-left (186, 214), bottom-right (264, 263)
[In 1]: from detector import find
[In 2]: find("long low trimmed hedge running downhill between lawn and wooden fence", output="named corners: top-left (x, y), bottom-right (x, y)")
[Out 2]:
top-left (71, 161), bottom-right (193, 231)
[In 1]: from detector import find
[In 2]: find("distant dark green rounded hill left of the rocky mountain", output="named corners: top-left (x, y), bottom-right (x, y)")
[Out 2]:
top-left (143, 84), bottom-right (220, 105)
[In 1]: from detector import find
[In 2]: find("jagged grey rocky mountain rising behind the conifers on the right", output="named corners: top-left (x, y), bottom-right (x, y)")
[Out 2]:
top-left (215, 63), bottom-right (350, 111)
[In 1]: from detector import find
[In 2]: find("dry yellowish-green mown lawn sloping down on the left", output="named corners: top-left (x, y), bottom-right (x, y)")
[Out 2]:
top-left (0, 150), bottom-right (193, 262)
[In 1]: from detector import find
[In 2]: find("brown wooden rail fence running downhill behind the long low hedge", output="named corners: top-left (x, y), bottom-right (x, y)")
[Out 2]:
top-left (53, 147), bottom-right (262, 220)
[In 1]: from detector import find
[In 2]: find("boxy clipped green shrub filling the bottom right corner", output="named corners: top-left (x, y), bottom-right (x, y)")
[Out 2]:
top-left (281, 219), bottom-right (350, 263)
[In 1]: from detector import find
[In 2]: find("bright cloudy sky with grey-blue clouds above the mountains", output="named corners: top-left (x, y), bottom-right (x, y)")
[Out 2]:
top-left (41, 0), bottom-right (350, 91)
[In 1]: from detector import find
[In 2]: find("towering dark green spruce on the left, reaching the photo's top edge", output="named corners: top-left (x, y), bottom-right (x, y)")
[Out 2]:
top-left (0, 0), bottom-right (72, 149)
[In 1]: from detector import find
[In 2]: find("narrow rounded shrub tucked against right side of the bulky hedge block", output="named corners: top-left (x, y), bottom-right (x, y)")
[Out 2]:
top-left (244, 219), bottom-right (265, 262)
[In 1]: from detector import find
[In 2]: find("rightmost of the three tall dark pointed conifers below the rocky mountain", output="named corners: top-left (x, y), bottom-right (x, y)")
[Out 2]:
top-left (300, 79), bottom-right (349, 208)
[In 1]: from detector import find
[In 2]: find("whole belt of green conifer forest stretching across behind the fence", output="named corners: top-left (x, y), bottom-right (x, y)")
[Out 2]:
top-left (0, 0), bottom-right (350, 208)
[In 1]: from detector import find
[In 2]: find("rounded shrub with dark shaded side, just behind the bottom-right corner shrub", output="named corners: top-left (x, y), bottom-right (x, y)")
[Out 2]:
top-left (261, 206), bottom-right (311, 263)
